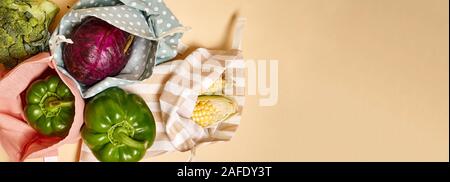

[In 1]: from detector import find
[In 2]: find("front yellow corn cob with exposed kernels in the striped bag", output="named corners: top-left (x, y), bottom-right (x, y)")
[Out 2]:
top-left (192, 96), bottom-right (237, 127)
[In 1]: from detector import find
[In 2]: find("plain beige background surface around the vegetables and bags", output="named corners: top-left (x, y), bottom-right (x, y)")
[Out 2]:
top-left (0, 0), bottom-right (449, 161)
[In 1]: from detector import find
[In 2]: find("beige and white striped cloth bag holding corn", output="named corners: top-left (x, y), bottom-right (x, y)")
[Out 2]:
top-left (80, 19), bottom-right (245, 162)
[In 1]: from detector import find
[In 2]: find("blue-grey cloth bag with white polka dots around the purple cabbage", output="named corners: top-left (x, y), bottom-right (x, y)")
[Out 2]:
top-left (50, 0), bottom-right (186, 98)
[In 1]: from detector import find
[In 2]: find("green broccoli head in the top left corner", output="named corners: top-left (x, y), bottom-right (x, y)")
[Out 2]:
top-left (0, 0), bottom-right (59, 68)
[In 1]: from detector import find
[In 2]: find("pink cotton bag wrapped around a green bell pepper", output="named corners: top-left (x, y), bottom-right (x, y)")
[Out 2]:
top-left (0, 53), bottom-right (84, 162)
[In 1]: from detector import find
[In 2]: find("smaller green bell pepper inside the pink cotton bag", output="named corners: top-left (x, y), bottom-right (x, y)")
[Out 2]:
top-left (25, 76), bottom-right (75, 137)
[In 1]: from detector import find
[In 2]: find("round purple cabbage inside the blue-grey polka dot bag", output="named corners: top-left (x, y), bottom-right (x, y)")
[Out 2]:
top-left (63, 17), bottom-right (134, 86)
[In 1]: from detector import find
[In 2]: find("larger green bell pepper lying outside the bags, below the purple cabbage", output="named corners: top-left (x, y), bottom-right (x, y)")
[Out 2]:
top-left (81, 87), bottom-right (156, 162)
